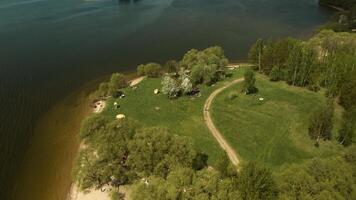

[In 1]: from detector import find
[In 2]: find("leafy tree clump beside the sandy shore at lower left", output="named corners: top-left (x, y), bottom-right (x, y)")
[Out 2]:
top-left (73, 120), bottom-right (138, 190)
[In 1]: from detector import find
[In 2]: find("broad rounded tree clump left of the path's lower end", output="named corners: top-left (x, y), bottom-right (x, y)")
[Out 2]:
top-left (128, 128), bottom-right (195, 178)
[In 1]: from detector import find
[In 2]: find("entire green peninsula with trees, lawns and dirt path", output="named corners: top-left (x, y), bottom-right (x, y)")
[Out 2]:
top-left (73, 31), bottom-right (356, 200)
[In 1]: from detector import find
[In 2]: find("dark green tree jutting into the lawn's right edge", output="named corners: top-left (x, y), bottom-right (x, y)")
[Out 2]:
top-left (308, 105), bottom-right (334, 145)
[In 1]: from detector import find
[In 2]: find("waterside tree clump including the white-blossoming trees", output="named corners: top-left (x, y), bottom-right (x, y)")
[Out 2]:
top-left (137, 46), bottom-right (229, 98)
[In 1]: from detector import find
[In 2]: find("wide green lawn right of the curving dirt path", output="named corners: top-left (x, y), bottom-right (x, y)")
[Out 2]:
top-left (211, 75), bottom-right (342, 168)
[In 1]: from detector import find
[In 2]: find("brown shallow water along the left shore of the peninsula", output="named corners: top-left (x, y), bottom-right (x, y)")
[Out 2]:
top-left (11, 79), bottom-right (96, 199)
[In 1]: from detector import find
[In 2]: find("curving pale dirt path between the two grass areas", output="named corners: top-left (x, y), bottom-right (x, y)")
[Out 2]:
top-left (204, 78), bottom-right (244, 165)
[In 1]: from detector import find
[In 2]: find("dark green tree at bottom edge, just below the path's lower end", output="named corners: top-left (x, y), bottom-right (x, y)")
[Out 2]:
top-left (238, 162), bottom-right (278, 200)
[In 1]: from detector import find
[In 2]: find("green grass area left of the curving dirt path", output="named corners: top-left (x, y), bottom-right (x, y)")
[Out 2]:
top-left (98, 70), bottom-right (246, 165)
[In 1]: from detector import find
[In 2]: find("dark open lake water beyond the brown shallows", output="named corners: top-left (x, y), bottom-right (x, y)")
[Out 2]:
top-left (0, 0), bottom-right (331, 199)
